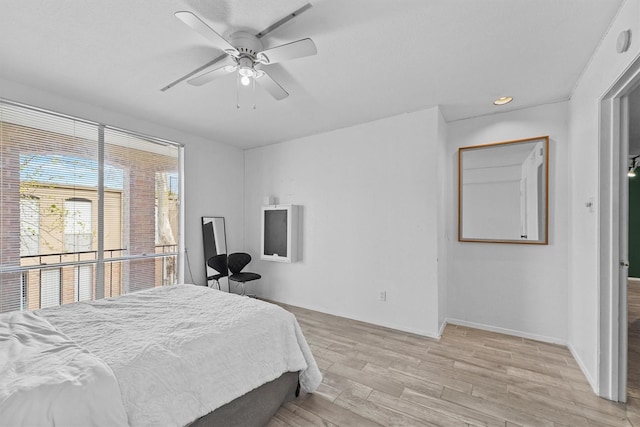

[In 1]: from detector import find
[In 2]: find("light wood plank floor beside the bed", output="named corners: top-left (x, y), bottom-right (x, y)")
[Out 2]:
top-left (268, 302), bottom-right (640, 427)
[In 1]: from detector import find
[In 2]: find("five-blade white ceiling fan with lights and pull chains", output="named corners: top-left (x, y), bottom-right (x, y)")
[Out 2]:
top-left (162, 4), bottom-right (317, 100)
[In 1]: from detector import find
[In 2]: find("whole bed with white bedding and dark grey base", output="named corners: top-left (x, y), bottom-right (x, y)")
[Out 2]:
top-left (0, 285), bottom-right (322, 427)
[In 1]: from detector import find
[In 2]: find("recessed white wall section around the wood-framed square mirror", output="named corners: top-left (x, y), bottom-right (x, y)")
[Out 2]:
top-left (447, 102), bottom-right (569, 343)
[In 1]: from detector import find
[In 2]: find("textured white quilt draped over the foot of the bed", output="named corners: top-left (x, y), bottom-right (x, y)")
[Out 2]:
top-left (39, 285), bottom-right (322, 426)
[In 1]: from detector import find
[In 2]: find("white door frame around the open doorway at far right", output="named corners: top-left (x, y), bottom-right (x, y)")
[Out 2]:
top-left (597, 58), bottom-right (640, 402)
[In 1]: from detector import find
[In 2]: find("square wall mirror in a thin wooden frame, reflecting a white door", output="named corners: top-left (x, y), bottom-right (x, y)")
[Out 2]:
top-left (458, 136), bottom-right (549, 245)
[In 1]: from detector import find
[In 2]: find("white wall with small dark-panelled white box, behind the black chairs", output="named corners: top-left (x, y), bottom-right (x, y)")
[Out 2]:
top-left (245, 108), bottom-right (444, 336)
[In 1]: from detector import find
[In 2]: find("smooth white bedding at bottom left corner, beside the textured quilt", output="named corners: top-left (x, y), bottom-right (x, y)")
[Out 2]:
top-left (0, 312), bottom-right (127, 427)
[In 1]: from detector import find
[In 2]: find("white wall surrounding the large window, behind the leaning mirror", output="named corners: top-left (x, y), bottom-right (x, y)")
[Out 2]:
top-left (0, 79), bottom-right (244, 284)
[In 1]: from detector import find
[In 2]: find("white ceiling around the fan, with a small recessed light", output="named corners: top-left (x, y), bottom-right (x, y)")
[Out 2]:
top-left (0, 0), bottom-right (622, 148)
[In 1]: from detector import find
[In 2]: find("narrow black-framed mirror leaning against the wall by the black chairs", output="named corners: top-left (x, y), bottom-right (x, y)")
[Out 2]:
top-left (202, 216), bottom-right (229, 290)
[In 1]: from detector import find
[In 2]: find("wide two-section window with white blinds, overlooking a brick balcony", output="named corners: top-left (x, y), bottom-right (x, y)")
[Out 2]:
top-left (0, 100), bottom-right (182, 312)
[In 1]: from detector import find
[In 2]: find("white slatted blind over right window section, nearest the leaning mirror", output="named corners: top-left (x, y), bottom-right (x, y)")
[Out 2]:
top-left (104, 128), bottom-right (179, 291)
